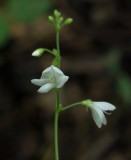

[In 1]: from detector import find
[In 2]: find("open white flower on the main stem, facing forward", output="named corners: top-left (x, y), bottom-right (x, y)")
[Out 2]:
top-left (31, 65), bottom-right (69, 93)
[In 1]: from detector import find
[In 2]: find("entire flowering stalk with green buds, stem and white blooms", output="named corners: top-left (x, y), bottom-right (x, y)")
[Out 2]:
top-left (31, 10), bottom-right (115, 160)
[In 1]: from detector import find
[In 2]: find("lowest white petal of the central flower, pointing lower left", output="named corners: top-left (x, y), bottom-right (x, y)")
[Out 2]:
top-left (38, 83), bottom-right (54, 93)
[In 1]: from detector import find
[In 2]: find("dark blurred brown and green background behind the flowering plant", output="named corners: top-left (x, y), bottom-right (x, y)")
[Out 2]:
top-left (0, 0), bottom-right (131, 160)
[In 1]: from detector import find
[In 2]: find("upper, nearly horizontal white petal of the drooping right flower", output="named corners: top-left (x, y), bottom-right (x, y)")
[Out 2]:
top-left (93, 102), bottom-right (116, 111)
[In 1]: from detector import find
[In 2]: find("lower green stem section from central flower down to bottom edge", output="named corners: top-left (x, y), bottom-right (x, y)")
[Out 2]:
top-left (54, 91), bottom-right (60, 160)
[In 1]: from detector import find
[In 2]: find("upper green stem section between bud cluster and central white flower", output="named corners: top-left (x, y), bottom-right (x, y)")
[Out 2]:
top-left (56, 29), bottom-right (61, 68)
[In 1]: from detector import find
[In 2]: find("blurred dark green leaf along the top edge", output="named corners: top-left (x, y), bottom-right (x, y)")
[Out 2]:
top-left (9, 0), bottom-right (51, 22)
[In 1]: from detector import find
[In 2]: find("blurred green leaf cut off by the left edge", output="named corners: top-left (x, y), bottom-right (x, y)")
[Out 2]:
top-left (0, 15), bottom-right (9, 47)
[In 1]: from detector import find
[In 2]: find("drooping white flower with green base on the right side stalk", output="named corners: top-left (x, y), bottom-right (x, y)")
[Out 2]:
top-left (82, 100), bottom-right (116, 128)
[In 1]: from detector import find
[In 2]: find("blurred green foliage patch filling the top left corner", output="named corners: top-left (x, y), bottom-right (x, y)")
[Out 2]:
top-left (0, 0), bottom-right (53, 47)
